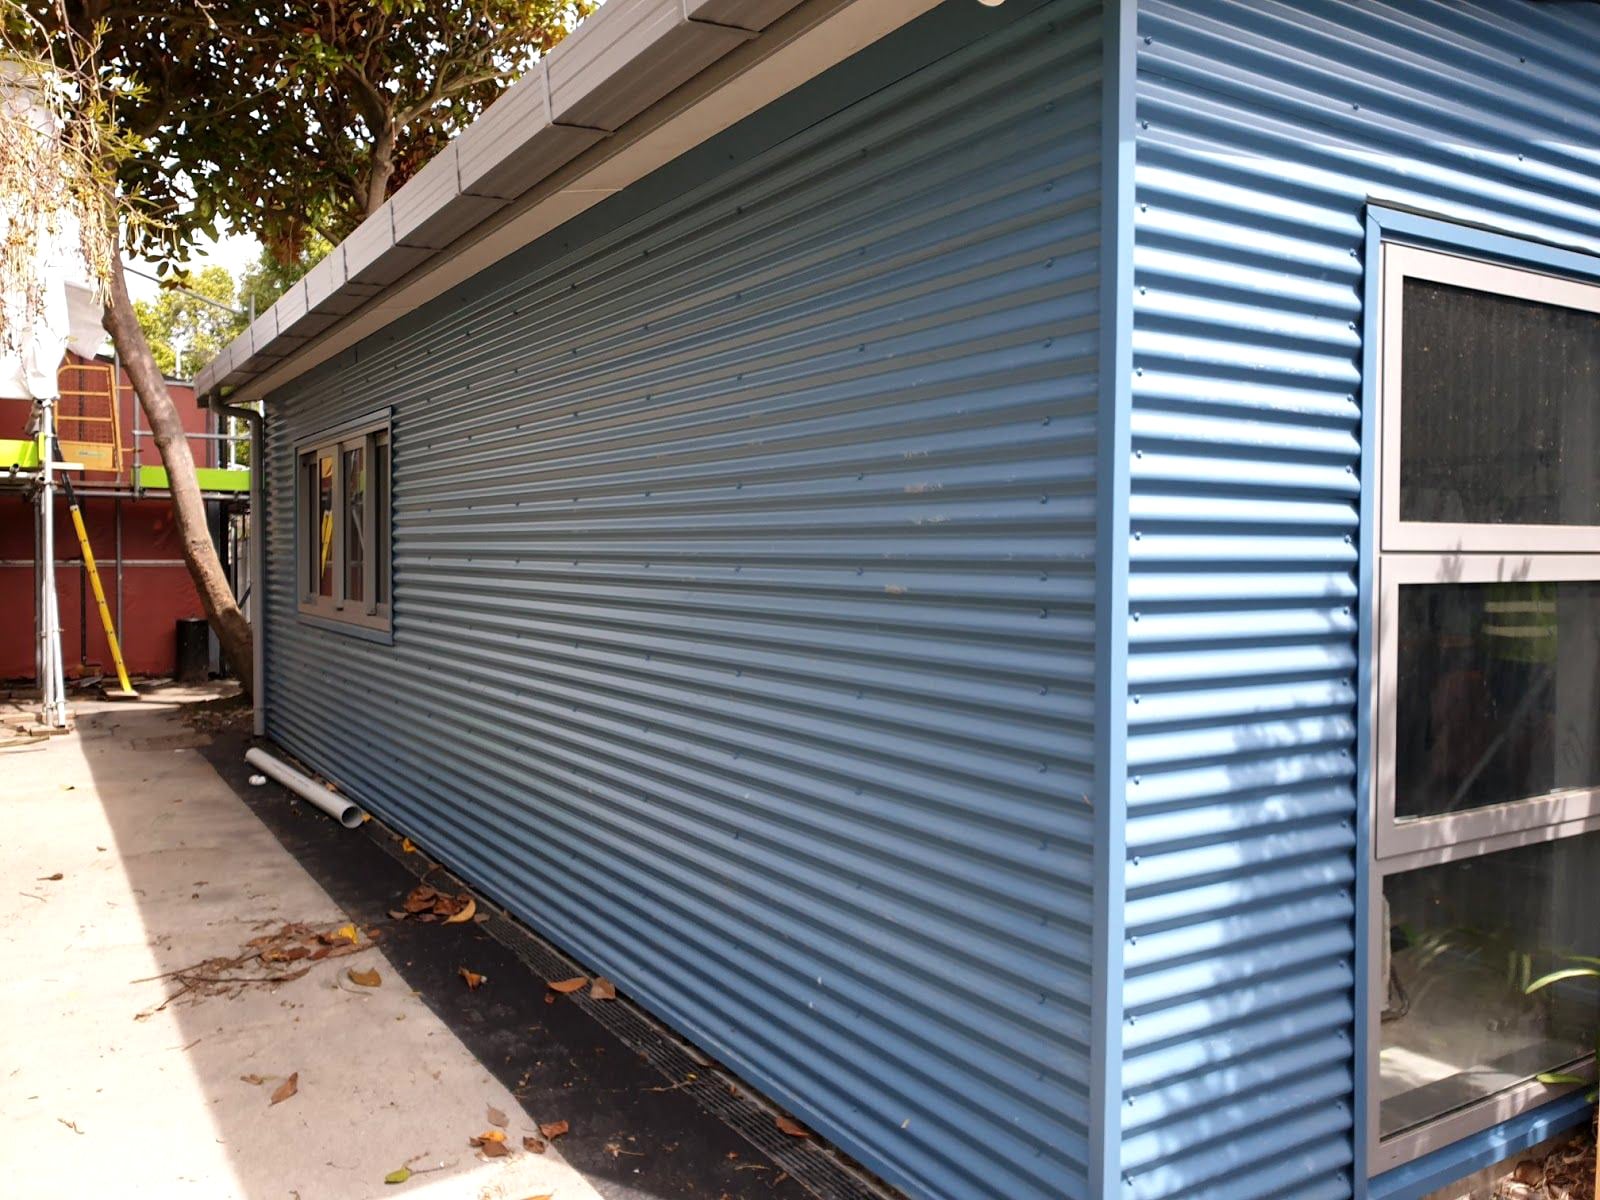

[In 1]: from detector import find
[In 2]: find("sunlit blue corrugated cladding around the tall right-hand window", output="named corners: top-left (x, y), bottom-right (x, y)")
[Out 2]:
top-left (1122, 0), bottom-right (1600, 1200)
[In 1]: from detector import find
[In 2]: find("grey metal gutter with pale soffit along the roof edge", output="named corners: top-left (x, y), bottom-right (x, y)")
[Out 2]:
top-left (195, 0), bottom-right (936, 402)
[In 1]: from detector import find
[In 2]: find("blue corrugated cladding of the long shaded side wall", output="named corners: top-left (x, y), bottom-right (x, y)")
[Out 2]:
top-left (267, 0), bottom-right (1101, 1200)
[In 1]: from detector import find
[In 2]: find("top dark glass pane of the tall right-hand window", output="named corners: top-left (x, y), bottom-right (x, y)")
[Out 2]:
top-left (1400, 278), bottom-right (1600, 525)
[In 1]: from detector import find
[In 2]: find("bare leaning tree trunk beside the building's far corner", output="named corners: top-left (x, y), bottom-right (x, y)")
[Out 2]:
top-left (104, 253), bottom-right (256, 693)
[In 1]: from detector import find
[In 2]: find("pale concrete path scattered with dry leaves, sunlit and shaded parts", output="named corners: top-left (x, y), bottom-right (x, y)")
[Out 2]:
top-left (0, 688), bottom-right (600, 1200)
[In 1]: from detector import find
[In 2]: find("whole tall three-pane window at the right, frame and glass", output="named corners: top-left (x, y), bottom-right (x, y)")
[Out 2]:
top-left (1368, 245), bottom-right (1600, 1171)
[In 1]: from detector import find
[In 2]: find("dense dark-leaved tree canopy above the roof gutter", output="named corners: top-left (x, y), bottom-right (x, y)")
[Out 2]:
top-left (64, 0), bottom-right (595, 264)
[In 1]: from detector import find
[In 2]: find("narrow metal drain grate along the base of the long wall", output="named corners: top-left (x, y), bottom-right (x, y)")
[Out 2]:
top-left (363, 816), bottom-right (904, 1200)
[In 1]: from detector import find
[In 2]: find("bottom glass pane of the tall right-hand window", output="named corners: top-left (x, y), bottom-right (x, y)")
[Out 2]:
top-left (1378, 834), bottom-right (1600, 1136)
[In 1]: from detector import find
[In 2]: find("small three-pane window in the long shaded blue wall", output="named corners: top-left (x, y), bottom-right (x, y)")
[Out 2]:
top-left (298, 418), bottom-right (390, 630)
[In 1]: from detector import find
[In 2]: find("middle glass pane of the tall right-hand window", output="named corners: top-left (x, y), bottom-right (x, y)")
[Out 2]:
top-left (1395, 582), bottom-right (1600, 819)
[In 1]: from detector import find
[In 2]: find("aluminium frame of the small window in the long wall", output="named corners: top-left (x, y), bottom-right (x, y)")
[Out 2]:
top-left (294, 410), bottom-right (394, 640)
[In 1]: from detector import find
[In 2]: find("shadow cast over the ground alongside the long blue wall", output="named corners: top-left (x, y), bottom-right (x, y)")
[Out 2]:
top-left (60, 693), bottom-right (810, 1200)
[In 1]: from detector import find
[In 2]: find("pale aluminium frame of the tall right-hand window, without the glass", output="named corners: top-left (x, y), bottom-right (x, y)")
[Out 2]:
top-left (1365, 237), bottom-right (1600, 1174)
